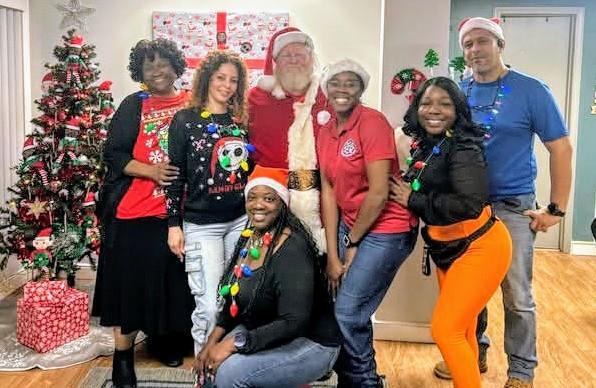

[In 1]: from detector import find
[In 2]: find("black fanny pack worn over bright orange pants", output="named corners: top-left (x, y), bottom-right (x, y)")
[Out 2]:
top-left (421, 209), bottom-right (497, 276)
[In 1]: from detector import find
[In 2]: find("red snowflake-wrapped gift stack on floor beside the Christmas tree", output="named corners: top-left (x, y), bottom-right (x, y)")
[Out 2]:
top-left (17, 281), bottom-right (89, 353)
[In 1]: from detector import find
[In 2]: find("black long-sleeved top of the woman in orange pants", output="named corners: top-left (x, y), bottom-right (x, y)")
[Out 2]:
top-left (407, 136), bottom-right (488, 225)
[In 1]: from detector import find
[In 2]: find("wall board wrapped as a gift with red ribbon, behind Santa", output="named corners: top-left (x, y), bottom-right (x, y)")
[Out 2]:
top-left (153, 12), bottom-right (289, 89)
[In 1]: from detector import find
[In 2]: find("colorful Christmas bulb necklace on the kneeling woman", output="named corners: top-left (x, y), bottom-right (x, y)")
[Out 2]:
top-left (219, 229), bottom-right (273, 317)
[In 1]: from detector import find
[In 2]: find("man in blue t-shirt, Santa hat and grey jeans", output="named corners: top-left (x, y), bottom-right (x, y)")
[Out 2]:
top-left (435, 18), bottom-right (572, 388)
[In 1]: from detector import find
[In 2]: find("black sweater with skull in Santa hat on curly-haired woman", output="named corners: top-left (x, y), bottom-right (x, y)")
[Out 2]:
top-left (166, 108), bottom-right (250, 226)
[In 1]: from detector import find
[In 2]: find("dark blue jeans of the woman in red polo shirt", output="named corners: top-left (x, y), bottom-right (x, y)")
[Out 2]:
top-left (335, 222), bottom-right (415, 387)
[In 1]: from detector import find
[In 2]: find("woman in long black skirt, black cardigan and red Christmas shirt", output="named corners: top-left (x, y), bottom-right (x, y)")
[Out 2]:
top-left (93, 39), bottom-right (193, 387)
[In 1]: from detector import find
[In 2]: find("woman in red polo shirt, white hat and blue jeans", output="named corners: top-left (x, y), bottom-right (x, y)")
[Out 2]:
top-left (317, 59), bottom-right (416, 387)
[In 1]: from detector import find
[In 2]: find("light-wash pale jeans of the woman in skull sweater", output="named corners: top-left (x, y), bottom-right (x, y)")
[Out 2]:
top-left (184, 215), bottom-right (246, 354)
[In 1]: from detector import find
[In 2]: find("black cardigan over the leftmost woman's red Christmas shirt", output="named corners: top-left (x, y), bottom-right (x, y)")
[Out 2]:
top-left (95, 92), bottom-right (143, 246)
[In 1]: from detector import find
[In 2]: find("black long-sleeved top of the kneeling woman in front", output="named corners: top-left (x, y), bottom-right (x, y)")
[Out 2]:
top-left (217, 232), bottom-right (341, 353)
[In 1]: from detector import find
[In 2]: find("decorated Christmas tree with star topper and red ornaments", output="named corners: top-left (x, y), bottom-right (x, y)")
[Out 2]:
top-left (0, 30), bottom-right (114, 279)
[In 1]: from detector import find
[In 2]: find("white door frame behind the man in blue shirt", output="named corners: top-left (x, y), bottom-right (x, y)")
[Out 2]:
top-left (494, 7), bottom-right (584, 253)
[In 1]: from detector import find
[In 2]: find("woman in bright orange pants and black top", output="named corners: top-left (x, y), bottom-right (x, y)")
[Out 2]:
top-left (391, 77), bottom-right (511, 388)
